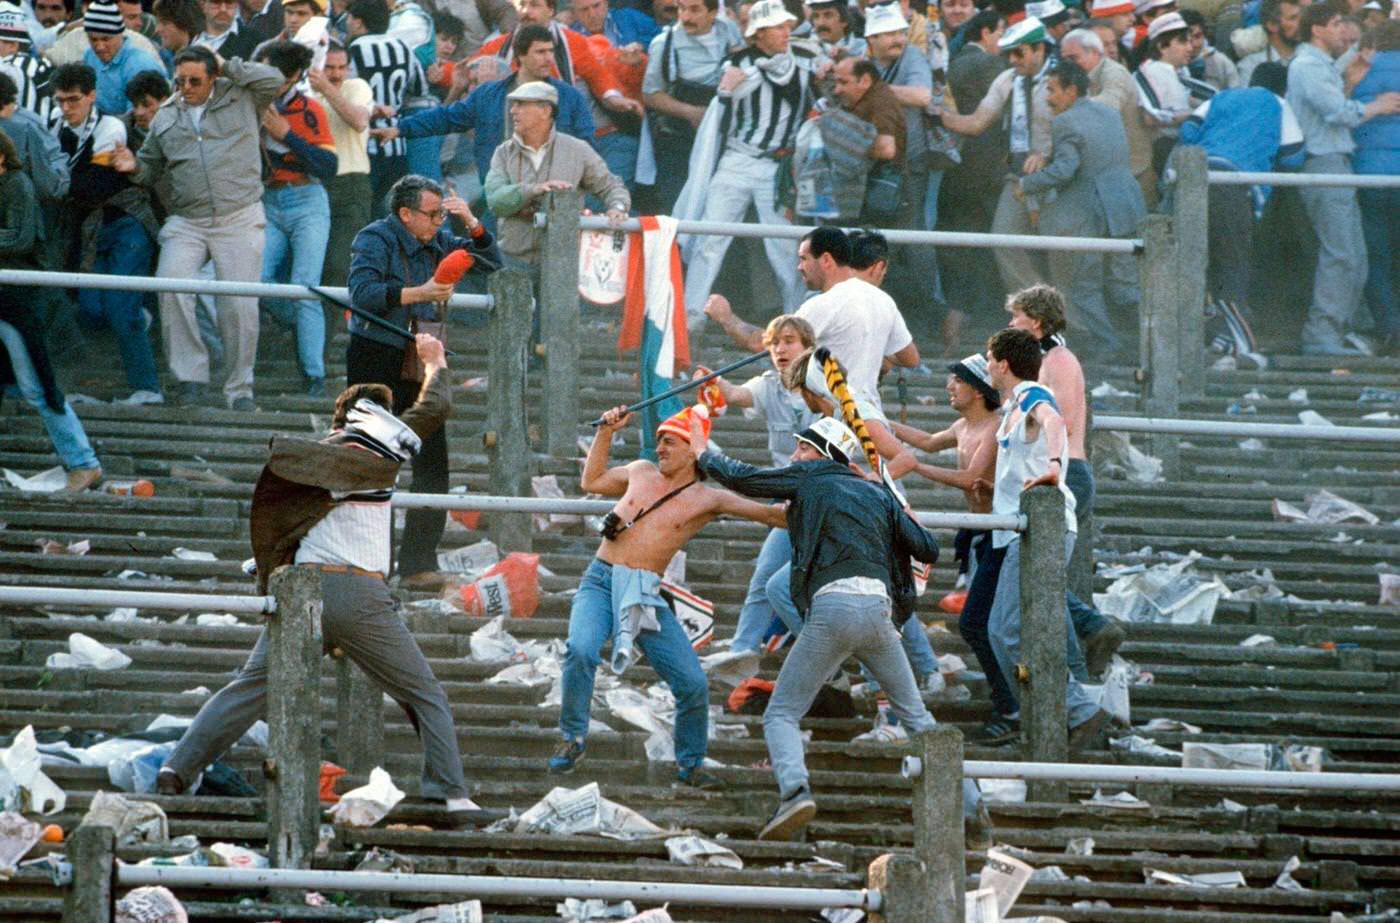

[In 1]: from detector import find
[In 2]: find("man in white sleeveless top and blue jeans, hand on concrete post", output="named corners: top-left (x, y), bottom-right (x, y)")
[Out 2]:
top-left (963, 328), bottom-right (1110, 749)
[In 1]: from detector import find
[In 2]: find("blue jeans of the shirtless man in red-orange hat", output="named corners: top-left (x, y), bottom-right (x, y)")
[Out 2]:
top-left (559, 557), bottom-right (710, 770)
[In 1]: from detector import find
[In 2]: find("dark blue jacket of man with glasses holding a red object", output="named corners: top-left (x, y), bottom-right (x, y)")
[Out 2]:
top-left (349, 214), bottom-right (501, 346)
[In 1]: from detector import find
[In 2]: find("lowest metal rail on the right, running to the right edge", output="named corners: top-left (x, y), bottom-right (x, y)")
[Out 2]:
top-left (963, 759), bottom-right (1400, 791)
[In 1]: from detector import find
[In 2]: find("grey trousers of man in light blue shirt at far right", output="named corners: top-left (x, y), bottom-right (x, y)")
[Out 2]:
top-left (1298, 154), bottom-right (1366, 350)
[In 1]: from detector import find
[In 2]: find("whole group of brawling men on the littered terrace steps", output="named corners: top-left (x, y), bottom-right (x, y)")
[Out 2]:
top-left (147, 227), bottom-right (1123, 843)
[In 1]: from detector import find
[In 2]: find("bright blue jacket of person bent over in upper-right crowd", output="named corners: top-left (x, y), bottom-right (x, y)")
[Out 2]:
top-left (1180, 87), bottom-right (1303, 172)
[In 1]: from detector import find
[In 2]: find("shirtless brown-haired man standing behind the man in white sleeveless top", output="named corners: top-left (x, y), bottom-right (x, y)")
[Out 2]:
top-left (1007, 284), bottom-right (1126, 682)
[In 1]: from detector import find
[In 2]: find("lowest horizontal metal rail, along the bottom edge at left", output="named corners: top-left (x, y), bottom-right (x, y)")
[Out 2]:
top-left (116, 863), bottom-right (882, 912)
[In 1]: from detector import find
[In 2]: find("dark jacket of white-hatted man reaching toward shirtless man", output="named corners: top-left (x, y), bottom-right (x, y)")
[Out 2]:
top-left (697, 451), bottom-right (938, 625)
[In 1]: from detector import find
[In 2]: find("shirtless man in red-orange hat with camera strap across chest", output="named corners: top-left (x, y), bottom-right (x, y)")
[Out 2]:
top-left (549, 406), bottom-right (787, 789)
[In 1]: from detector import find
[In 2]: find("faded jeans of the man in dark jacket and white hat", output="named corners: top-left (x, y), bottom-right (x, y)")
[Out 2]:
top-left (763, 592), bottom-right (981, 817)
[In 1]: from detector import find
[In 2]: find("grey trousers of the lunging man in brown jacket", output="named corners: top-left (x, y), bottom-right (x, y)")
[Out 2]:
top-left (165, 574), bottom-right (468, 800)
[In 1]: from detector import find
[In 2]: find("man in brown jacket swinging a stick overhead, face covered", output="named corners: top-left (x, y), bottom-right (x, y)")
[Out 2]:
top-left (157, 333), bottom-right (500, 826)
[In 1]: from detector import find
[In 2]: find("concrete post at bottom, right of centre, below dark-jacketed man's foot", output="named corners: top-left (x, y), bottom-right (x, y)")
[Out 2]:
top-left (914, 724), bottom-right (967, 923)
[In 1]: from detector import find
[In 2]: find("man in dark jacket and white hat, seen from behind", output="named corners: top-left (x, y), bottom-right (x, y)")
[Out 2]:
top-left (690, 417), bottom-right (991, 843)
